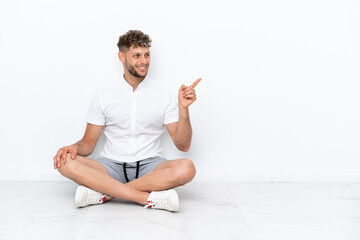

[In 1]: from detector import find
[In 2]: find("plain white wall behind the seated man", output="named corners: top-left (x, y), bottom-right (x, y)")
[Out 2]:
top-left (0, 0), bottom-right (360, 181)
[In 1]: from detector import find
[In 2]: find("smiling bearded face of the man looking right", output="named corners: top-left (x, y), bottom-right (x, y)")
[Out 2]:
top-left (123, 47), bottom-right (150, 78)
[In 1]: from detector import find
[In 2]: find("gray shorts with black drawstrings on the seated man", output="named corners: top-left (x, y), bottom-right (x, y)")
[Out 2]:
top-left (95, 156), bottom-right (166, 183)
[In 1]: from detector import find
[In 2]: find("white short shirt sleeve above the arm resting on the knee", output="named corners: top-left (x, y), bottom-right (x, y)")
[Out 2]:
top-left (86, 91), bottom-right (105, 126)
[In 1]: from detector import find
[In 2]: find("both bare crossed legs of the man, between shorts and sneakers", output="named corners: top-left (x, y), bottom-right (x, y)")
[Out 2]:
top-left (58, 154), bottom-right (196, 205)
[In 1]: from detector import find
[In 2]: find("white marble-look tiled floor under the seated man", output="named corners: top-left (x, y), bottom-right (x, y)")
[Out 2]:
top-left (0, 182), bottom-right (360, 240)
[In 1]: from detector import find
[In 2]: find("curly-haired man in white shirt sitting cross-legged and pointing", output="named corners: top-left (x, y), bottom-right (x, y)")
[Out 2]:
top-left (53, 30), bottom-right (201, 211)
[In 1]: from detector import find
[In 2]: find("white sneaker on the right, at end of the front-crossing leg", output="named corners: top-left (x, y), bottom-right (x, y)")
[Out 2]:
top-left (145, 189), bottom-right (179, 212)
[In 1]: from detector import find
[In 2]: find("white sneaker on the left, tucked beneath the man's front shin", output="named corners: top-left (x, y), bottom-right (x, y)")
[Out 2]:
top-left (75, 186), bottom-right (111, 207)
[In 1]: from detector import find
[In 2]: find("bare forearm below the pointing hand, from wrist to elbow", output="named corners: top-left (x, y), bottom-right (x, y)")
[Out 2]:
top-left (175, 106), bottom-right (192, 152)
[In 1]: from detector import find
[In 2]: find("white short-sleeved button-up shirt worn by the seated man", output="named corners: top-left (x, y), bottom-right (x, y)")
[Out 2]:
top-left (86, 77), bottom-right (179, 162)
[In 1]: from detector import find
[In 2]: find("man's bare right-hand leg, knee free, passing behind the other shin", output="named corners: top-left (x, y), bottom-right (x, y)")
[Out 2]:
top-left (126, 159), bottom-right (196, 192)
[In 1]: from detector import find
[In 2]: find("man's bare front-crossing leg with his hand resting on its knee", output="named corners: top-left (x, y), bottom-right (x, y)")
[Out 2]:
top-left (58, 154), bottom-right (149, 205)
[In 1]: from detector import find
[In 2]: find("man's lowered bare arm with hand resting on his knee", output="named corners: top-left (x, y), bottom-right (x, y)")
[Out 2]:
top-left (53, 123), bottom-right (104, 169)
